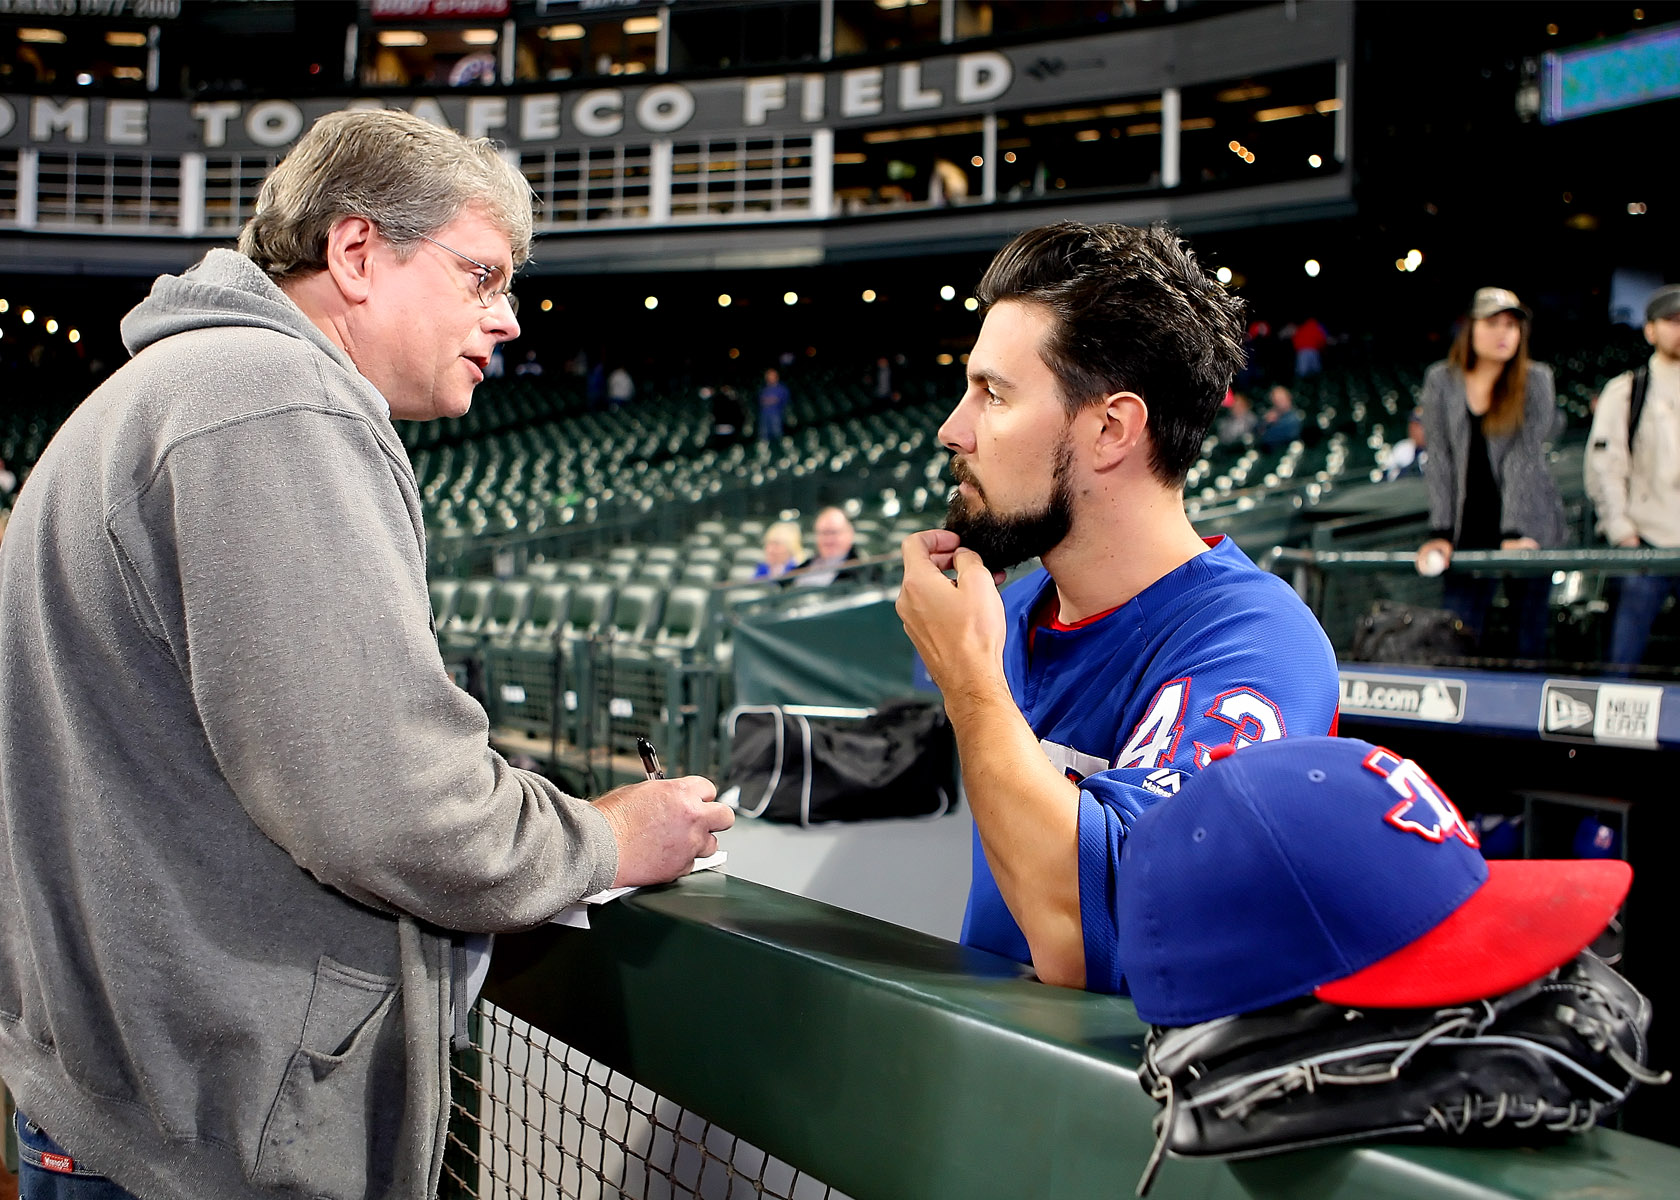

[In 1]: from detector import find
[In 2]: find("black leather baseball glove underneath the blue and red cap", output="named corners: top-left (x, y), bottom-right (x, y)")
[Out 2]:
top-left (1137, 951), bottom-right (1668, 1195)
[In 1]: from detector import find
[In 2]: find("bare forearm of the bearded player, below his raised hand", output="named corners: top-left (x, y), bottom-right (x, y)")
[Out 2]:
top-left (946, 681), bottom-right (1085, 987)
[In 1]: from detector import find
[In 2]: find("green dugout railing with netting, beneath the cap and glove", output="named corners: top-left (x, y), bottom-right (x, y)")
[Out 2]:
top-left (455, 872), bottom-right (1680, 1200)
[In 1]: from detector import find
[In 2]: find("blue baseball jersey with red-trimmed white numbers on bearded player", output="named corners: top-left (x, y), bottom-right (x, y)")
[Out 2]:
top-left (963, 538), bottom-right (1337, 992)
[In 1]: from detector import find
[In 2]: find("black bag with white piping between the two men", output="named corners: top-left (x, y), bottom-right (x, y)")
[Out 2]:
top-left (719, 701), bottom-right (956, 825)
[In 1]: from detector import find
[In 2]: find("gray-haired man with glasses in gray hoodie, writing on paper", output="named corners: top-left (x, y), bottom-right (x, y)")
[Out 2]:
top-left (0, 113), bottom-right (732, 1200)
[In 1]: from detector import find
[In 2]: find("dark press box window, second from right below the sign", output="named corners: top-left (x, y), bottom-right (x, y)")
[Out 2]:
top-left (998, 92), bottom-right (1161, 203)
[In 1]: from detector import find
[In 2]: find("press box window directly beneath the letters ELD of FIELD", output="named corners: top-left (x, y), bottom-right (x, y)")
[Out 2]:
top-left (833, 118), bottom-right (984, 217)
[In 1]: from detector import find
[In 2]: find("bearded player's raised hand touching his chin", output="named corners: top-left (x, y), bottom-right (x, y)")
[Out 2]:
top-left (897, 529), bottom-right (1008, 694)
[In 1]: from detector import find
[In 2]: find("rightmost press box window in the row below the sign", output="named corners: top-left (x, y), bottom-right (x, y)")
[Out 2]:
top-left (1179, 62), bottom-right (1341, 188)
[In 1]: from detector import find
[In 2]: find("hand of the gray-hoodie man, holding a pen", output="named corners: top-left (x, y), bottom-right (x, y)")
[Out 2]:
top-left (595, 775), bottom-right (734, 887)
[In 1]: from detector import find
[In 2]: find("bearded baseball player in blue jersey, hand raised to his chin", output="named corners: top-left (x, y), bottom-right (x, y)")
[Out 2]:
top-left (899, 224), bottom-right (1337, 992)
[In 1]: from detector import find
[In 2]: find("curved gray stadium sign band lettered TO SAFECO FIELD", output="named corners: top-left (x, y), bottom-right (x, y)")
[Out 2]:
top-left (0, 0), bottom-right (1352, 153)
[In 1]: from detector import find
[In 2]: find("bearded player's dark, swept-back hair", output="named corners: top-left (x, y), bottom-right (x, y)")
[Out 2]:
top-left (976, 222), bottom-right (1243, 487)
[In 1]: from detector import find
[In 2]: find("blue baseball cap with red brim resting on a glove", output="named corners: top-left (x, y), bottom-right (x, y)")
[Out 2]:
top-left (1116, 738), bottom-right (1633, 1025)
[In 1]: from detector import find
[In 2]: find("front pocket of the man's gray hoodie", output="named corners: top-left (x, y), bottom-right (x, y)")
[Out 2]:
top-left (250, 955), bottom-right (405, 1200)
